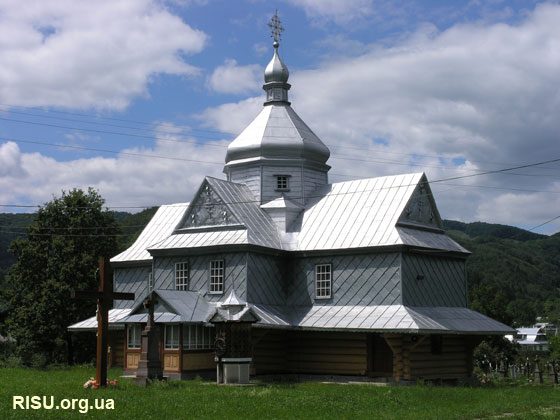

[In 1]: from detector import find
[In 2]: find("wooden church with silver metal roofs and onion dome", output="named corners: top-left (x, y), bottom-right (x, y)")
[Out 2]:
top-left (69, 24), bottom-right (513, 381)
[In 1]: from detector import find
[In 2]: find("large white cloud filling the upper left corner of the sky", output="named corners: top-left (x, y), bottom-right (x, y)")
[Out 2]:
top-left (0, 0), bottom-right (207, 110)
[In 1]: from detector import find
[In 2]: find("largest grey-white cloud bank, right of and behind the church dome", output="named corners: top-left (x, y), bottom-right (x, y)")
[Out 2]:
top-left (201, 3), bottom-right (560, 230)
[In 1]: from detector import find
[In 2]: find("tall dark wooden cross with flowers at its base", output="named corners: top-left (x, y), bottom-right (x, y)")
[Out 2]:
top-left (71, 257), bottom-right (134, 386)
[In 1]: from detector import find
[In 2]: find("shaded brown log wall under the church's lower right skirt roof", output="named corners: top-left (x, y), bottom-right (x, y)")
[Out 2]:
top-left (251, 329), bottom-right (473, 381)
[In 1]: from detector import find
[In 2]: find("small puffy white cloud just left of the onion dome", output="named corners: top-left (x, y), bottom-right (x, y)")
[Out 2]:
top-left (207, 59), bottom-right (263, 94)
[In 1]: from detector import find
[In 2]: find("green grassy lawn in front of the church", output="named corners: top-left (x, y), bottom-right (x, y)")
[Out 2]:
top-left (0, 367), bottom-right (560, 420)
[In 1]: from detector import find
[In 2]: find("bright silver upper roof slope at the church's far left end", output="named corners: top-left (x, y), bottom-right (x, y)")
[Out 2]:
top-left (111, 203), bottom-right (189, 262)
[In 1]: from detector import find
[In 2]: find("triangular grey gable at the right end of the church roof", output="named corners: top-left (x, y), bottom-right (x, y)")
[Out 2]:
top-left (397, 175), bottom-right (443, 230)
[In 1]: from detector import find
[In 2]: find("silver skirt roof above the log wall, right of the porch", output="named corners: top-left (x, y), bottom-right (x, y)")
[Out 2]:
top-left (252, 304), bottom-right (515, 334)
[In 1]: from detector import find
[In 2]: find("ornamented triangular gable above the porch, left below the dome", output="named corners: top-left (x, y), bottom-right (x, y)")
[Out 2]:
top-left (176, 180), bottom-right (239, 229)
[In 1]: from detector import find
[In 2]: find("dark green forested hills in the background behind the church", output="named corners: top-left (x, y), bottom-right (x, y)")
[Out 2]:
top-left (0, 213), bottom-right (560, 326)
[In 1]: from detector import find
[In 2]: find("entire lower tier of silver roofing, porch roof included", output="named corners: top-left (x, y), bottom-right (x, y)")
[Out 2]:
top-left (68, 302), bottom-right (515, 334)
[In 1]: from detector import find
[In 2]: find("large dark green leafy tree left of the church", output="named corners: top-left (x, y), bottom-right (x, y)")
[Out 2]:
top-left (5, 188), bottom-right (118, 364)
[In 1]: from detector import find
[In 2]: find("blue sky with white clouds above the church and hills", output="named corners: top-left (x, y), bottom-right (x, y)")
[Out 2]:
top-left (0, 0), bottom-right (560, 234)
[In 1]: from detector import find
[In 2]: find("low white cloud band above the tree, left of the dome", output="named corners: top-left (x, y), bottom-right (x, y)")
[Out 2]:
top-left (0, 124), bottom-right (227, 211)
